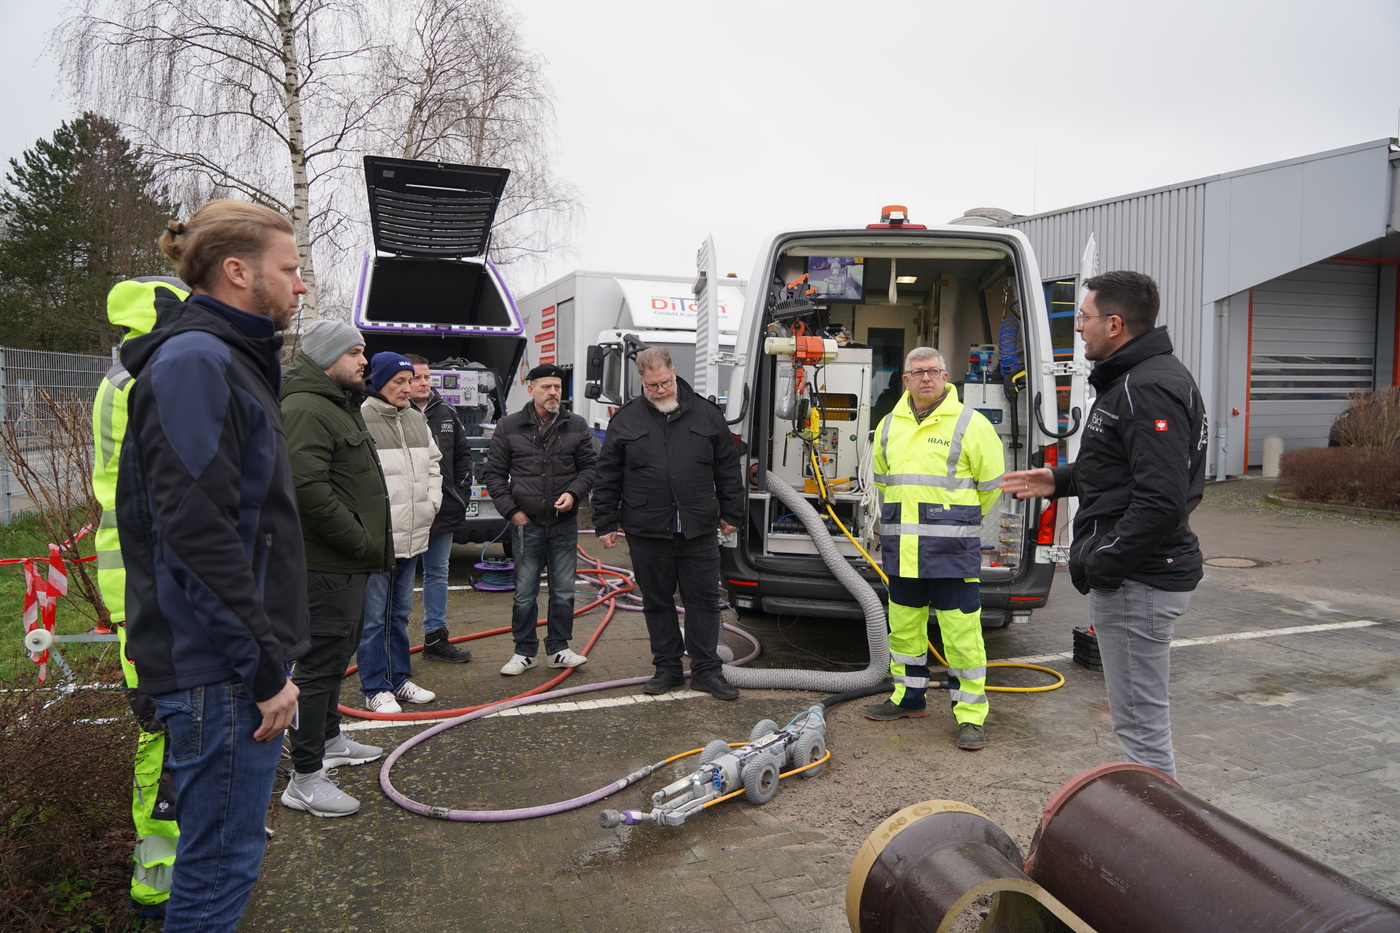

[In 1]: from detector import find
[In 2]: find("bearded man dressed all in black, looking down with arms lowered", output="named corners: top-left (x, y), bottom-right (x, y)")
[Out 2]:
top-left (594, 346), bottom-right (743, 699)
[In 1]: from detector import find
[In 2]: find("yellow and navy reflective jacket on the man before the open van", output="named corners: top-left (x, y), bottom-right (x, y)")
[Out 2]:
top-left (875, 385), bottom-right (1005, 579)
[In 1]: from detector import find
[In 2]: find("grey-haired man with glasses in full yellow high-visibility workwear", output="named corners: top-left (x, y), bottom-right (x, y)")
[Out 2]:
top-left (865, 346), bottom-right (1005, 751)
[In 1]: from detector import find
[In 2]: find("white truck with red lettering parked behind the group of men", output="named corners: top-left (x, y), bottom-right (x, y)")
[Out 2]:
top-left (508, 272), bottom-right (745, 440)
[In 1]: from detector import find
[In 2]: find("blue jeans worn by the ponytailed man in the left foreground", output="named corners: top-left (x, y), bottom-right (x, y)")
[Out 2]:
top-left (151, 679), bottom-right (281, 933)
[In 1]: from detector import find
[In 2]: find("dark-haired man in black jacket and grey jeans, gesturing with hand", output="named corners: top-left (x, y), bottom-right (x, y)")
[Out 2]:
top-left (1001, 272), bottom-right (1210, 778)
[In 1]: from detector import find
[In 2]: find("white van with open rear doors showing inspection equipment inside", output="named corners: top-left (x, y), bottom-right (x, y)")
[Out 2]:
top-left (720, 206), bottom-right (1084, 626)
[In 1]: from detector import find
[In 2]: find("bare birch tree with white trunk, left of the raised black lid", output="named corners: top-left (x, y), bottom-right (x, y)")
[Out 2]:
top-left (56, 0), bottom-right (389, 317)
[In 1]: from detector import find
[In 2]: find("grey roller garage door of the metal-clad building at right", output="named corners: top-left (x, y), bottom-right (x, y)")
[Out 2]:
top-left (1249, 262), bottom-right (1378, 465)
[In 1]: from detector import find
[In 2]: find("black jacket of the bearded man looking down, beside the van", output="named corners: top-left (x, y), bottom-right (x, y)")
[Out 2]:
top-left (594, 377), bottom-right (743, 538)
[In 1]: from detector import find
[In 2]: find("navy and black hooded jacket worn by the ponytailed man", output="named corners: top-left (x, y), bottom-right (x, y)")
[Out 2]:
top-left (116, 296), bottom-right (309, 702)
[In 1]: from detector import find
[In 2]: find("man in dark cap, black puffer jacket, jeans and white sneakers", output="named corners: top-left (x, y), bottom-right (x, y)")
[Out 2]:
top-left (484, 363), bottom-right (598, 677)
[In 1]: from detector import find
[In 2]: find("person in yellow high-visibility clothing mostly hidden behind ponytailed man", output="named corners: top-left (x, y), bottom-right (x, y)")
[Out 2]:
top-left (92, 276), bottom-right (189, 916)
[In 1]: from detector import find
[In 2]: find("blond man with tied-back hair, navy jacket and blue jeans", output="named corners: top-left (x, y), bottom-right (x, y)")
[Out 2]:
top-left (116, 200), bottom-right (309, 933)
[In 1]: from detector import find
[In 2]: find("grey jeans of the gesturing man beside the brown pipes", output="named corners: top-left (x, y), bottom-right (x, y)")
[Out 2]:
top-left (1089, 580), bottom-right (1191, 778)
